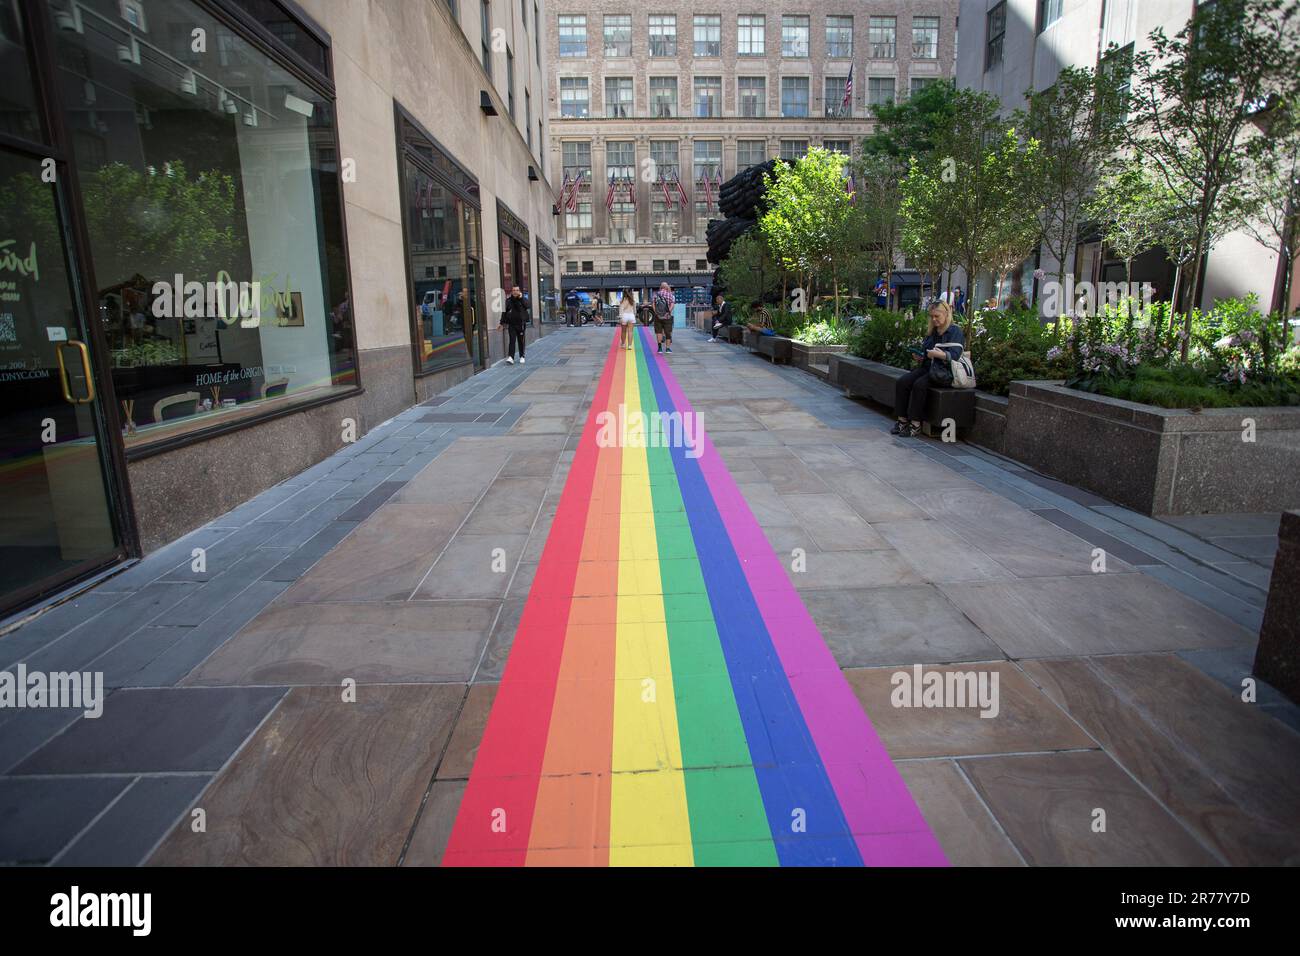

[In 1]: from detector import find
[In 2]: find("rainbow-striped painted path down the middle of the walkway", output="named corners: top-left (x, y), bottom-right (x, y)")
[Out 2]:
top-left (443, 329), bottom-right (946, 866)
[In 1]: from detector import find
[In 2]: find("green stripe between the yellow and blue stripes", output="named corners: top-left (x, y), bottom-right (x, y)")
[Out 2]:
top-left (633, 334), bottom-right (779, 866)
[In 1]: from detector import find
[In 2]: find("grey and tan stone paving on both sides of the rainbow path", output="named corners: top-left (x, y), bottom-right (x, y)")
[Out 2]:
top-left (0, 329), bottom-right (1300, 865)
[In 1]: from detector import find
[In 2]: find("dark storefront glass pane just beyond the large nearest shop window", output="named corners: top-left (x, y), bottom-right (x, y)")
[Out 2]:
top-left (406, 160), bottom-right (478, 373)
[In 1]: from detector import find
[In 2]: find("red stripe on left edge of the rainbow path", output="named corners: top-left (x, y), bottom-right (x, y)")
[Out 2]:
top-left (442, 338), bottom-right (618, 866)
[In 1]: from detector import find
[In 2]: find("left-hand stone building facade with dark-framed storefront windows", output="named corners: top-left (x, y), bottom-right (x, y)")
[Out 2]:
top-left (0, 0), bottom-right (558, 622)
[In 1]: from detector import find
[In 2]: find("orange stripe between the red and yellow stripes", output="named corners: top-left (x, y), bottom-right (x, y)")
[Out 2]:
top-left (528, 340), bottom-right (628, 866)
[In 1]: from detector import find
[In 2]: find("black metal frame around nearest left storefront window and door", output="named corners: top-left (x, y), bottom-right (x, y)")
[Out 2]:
top-left (10, 0), bottom-right (365, 613)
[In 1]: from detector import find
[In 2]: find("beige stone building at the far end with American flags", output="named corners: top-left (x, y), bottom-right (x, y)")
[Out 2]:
top-left (546, 0), bottom-right (957, 286)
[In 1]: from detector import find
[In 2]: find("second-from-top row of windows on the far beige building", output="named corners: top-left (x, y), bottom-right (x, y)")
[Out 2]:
top-left (559, 75), bottom-right (939, 120)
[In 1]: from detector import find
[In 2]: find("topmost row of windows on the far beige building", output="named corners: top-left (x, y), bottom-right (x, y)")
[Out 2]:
top-left (559, 13), bottom-right (939, 60)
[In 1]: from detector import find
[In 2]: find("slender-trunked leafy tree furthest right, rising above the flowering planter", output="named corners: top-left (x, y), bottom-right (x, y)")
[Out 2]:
top-left (1125, 0), bottom-right (1300, 359)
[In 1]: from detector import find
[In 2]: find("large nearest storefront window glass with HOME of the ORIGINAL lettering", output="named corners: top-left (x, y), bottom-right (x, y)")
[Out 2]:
top-left (55, 0), bottom-right (356, 447)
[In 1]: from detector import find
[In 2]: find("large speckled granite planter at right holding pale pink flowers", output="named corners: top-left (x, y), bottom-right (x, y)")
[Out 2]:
top-left (1001, 381), bottom-right (1300, 515)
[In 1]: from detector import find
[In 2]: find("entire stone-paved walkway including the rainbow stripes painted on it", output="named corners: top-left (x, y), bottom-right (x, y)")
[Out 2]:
top-left (0, 329), bottom-right (1300, 866)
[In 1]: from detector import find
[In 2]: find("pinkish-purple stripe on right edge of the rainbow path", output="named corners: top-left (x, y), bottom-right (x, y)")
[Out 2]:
top-left (660, 351), bottom-right (948, 866)
